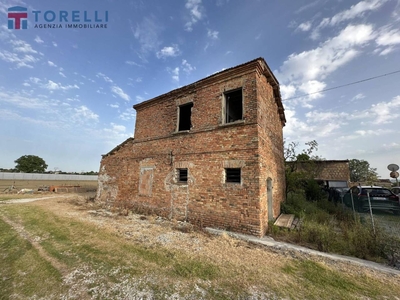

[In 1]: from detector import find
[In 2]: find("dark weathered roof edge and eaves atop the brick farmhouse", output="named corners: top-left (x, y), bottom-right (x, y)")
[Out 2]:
top-left (133, 57), bottom-right (286, 125)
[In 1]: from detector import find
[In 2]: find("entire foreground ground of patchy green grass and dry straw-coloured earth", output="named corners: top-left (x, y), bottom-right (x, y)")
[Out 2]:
top-left (0, 195), bottom-right (400, 299)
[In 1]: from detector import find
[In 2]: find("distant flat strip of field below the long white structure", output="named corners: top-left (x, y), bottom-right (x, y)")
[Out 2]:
top-left (0, 180), bottom-right (97, 193)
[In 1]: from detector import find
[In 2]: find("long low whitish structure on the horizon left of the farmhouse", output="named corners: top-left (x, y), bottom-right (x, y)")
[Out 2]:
top-left (0, 172), bottom-right (98, 181)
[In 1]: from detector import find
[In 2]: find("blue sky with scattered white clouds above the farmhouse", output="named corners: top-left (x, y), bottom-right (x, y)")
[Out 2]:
top-left (0, 0), bottom-right (400, 178)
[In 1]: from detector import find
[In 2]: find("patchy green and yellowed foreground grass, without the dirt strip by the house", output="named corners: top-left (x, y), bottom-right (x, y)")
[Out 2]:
top-left (0, 200), bottom-right (400, 299)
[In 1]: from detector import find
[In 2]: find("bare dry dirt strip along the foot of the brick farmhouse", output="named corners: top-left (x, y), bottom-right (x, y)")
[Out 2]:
top-left (0, 194), bottom-right (400, 298)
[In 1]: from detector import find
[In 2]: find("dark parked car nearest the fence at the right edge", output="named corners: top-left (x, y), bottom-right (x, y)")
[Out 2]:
top-left (343, 186), bottom-right (400, 215)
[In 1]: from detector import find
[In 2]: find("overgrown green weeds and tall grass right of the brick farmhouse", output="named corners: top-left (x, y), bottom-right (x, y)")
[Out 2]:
top-left (269, 192), bottom-right (400, 266)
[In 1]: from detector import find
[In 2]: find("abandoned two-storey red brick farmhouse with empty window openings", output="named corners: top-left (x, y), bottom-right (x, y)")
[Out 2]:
top-left (97, 58), bottom-right (286, 236)
